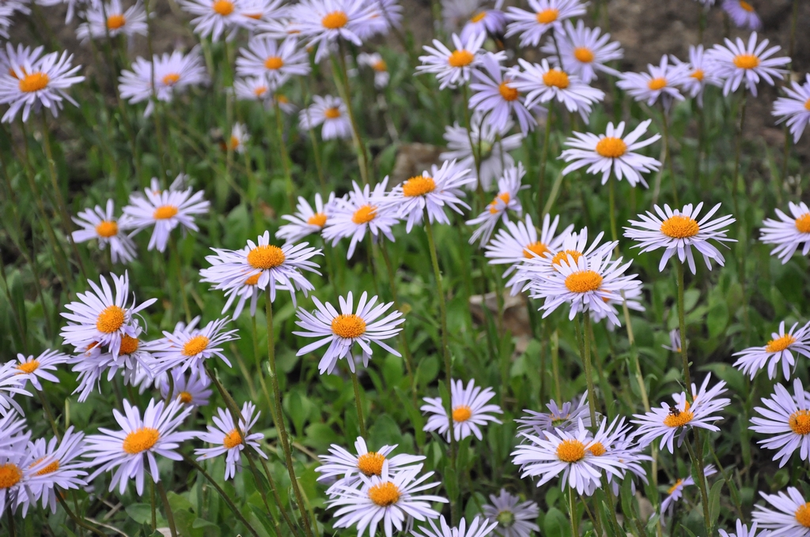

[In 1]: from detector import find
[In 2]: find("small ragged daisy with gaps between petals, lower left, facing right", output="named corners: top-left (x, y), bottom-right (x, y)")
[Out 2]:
top-left (194, 402), bottom-right (267, 480)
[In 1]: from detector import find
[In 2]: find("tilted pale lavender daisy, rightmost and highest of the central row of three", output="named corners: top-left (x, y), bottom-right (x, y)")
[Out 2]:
top-left (381, 160), bottom-right (475, 233)
